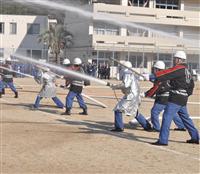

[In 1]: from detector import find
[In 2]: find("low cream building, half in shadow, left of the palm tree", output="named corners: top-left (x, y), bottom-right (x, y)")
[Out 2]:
top-left (0, 14), bottom-right (48, 59)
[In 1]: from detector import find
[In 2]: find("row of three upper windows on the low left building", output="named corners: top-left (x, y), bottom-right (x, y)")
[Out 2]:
top-left (0, 22), bottom-right (40, 34)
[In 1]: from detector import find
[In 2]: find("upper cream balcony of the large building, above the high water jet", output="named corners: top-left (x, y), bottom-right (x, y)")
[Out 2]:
top-left (93, 3), bottom-right (200, 27)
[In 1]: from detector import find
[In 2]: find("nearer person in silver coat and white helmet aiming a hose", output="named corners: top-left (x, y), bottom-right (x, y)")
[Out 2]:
top-left (108, 61), bottom-right (140, 132)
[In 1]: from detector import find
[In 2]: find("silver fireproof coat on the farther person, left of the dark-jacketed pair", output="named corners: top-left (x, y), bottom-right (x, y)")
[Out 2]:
top-left (35, 70), bottom-right (56, 98)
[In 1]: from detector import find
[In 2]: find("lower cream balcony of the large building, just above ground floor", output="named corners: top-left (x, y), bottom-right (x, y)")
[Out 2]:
top-left (92, 34), bottom-right (200, 54)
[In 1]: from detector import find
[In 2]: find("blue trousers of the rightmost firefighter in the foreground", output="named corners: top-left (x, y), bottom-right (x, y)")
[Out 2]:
top-left (158, 102), bottom-right (199, 144)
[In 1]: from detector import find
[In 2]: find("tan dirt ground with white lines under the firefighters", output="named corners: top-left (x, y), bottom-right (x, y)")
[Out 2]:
top-left (0, 78), bottom-right (200, 174)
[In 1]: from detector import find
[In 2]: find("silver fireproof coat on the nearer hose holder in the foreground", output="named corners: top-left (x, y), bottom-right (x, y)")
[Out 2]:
top-left (112, 69), bottom-right (140, 116)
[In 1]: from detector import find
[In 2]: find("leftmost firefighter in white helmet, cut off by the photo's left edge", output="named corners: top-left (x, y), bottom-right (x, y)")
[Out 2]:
top-left (0, 58), bottom-right (18, 98)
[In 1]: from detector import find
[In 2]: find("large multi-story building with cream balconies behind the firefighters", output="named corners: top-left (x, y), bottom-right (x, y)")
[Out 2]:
top-left (65, 0), bottom-right (200, 72)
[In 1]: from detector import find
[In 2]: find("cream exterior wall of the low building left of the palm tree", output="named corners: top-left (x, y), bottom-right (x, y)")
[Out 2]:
top-left (0, 15), bottom-right (48, 58)
